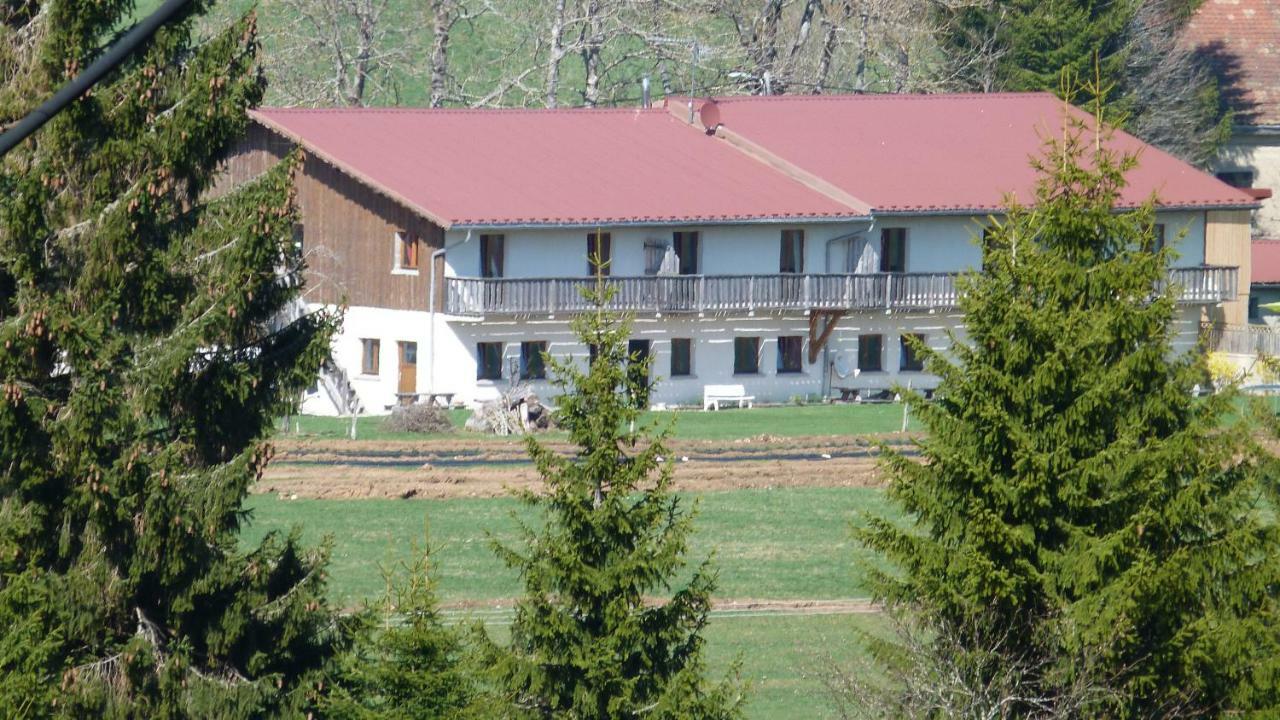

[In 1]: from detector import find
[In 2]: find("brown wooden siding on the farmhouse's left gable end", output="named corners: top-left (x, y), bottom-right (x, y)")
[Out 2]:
top-left (212, 123), bottom-right (444, 310)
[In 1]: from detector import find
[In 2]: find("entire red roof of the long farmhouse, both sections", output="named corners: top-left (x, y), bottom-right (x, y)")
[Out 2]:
top-left (253, 94), bottom-right (1257, 228)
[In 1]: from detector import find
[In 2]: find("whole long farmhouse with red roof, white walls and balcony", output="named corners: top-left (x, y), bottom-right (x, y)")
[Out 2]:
top-left (215, 94), bottom-right (1257, 413)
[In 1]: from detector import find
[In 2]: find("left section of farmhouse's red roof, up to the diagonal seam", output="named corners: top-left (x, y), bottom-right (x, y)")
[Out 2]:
top-left (253, 109), bottom-right (869, 227)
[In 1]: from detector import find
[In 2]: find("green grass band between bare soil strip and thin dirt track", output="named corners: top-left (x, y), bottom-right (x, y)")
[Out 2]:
top-left (242, 488), bottom-right (891, 606)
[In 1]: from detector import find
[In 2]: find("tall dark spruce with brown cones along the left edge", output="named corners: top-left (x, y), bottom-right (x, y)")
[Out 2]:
top-left (0, 0), bottom-right (334, 717)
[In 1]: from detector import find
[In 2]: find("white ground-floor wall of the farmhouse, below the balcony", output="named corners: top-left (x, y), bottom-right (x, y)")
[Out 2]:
top-left (302, 297), bottom-right (1199, 414)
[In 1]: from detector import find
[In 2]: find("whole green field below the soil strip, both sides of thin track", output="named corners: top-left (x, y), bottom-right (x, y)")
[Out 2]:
top-left (242, 488), bottom-right (892, 720)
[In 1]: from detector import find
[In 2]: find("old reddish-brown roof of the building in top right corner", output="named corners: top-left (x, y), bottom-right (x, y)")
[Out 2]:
top-left (1183, 0), bottom-right (1280, 126)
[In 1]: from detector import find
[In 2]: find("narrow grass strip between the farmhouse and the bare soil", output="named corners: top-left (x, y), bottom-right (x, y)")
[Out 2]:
top-left (279, 404), bottom-right (919, 442)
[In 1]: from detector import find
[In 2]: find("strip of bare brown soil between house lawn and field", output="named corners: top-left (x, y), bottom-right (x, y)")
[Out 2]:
top-left (255, 434), bottom-right (913, 498)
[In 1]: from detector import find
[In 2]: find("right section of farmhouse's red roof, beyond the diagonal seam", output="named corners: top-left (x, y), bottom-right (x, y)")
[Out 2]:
top-left (696, 94), bottom-right (1257, 213)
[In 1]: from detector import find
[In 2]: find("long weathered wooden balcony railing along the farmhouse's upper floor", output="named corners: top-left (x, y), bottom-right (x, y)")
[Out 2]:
top-left (444, 265), bottom-right (1236, 316)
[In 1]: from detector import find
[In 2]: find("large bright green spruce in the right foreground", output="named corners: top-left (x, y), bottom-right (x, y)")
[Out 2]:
top-left (858, 94), bottom-right (1280, 717)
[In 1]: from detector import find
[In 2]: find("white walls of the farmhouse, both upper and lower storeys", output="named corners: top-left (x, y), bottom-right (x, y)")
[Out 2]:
top-left (314, 211), bottom-right (1223, 413)
